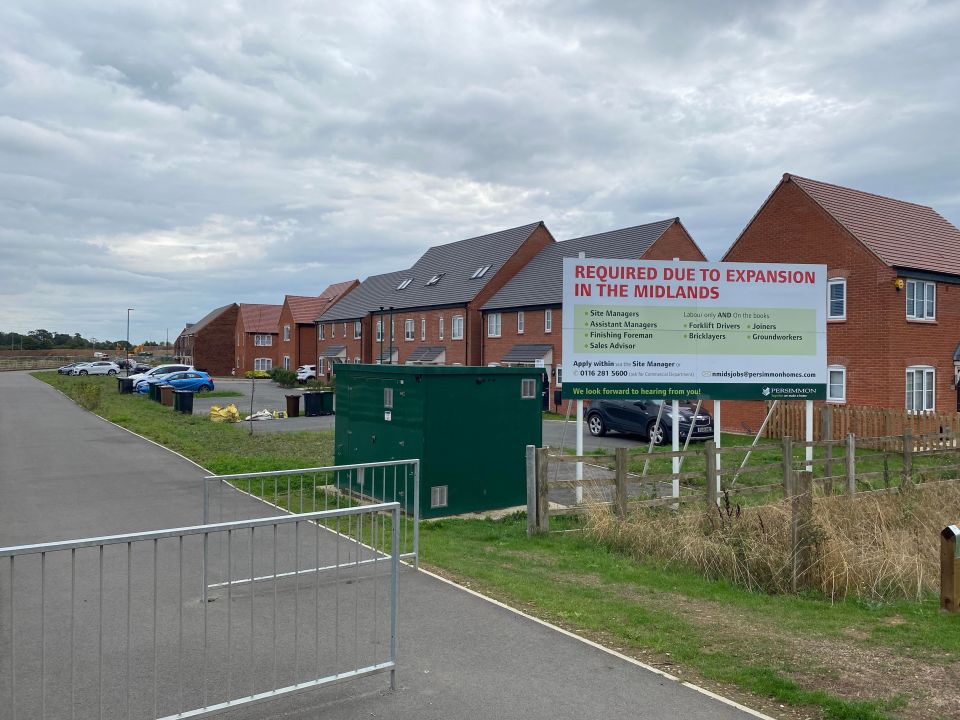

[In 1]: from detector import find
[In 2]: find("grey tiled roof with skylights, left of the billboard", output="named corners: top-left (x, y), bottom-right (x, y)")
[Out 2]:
top-left (320, 222), bottom-right (543, 322)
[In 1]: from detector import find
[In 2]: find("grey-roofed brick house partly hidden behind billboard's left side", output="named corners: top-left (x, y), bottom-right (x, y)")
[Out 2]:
top-left (482, 218), bottom-right (706, 411)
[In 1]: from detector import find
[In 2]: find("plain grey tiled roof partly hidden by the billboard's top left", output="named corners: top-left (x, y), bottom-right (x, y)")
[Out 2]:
top-left (483, 218), bottom-right (679, 310)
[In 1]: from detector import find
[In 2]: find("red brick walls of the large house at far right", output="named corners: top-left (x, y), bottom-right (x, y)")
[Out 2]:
top-left (721, 182), bottom-right (960, 430)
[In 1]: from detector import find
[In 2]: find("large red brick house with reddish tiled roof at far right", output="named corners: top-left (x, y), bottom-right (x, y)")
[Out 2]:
top-left (721, 174), bottom-right (960, 431)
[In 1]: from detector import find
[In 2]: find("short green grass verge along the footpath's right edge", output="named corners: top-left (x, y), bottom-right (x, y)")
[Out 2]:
top-left (37, 373), bottom-right (960, 720)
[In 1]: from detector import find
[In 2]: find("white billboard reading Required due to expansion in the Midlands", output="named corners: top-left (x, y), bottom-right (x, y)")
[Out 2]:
top-left (563, 258), bottom-right (827, 400)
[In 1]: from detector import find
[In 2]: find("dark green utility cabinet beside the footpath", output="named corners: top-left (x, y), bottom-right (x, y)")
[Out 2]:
top-left (334, 364), bottom-right (543, 517)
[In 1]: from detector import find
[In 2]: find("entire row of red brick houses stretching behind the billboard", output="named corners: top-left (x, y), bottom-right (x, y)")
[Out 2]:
top-left (177, 174), bottom-right (960, 430)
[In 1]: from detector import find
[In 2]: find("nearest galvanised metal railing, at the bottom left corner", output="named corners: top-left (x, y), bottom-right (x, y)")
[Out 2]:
top-left (0, 502), bottom-right (401, 720)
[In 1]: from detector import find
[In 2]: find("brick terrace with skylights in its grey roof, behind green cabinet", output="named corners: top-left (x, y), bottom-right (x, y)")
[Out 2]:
top-left (318, 222), bottom-right (554, 370)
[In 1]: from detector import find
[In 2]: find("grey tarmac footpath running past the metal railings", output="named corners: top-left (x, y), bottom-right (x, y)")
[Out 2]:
top-left (0, 373), bottom-right (757, 720)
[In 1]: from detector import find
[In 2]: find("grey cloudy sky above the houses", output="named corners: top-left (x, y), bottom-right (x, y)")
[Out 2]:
top-left (0, 0), bottom-right (960, 341)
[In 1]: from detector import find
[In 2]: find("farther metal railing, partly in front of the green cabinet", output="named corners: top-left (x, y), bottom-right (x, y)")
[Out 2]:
top-left (203, 459), bottom-right (420, 573)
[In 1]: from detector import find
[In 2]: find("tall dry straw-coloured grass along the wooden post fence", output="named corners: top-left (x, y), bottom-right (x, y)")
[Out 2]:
top-left (587, 482), bottom-right (960, 601)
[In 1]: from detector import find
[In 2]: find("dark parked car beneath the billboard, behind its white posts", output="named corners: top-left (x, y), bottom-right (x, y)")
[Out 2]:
top-left (587, 400), bottom-right (713, 445)
